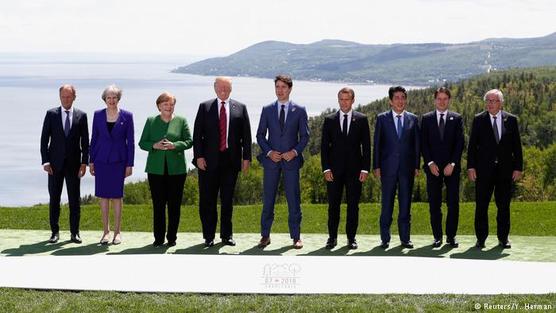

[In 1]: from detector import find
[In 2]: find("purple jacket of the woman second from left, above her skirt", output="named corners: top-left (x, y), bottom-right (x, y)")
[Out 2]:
top-left (91, 109), bottom-right (135, 166)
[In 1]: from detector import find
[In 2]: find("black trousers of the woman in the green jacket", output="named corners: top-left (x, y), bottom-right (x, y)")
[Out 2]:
top-left (148, 165), bottom-right (186, 243)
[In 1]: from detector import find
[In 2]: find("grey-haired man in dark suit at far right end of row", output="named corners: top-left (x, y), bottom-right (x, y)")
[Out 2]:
top-left (467, 89), bottom-right (523, 249)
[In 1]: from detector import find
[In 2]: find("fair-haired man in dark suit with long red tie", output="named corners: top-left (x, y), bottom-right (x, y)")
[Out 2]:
top-left (193, 77), bottom-right (251, 247)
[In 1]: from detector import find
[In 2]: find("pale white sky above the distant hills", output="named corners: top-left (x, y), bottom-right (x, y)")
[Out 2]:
top-left (0, 0), bottom-right (556, 56)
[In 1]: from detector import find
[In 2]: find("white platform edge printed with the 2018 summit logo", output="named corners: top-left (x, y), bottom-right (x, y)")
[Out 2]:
top-left (0, 254), bottom-right (556, 294)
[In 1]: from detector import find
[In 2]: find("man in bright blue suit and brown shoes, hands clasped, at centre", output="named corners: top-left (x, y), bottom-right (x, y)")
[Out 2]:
top-left (257, 75), bottom-right (309, 249)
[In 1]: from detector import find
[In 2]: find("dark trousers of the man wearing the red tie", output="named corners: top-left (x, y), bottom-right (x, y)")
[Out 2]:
top-left (199, 150), bottom-right (238, 240)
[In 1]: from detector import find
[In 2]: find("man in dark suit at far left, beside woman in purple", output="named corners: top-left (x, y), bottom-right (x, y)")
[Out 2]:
top-left (41, 85), bottom-right (89, 243)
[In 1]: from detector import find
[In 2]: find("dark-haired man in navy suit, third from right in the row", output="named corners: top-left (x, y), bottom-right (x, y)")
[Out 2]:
top-left (373, 86), bottom-right (421, 249)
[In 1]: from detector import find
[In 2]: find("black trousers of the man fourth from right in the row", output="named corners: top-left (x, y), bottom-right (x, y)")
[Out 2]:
top-left (326, 172), bottom-right (361, 242)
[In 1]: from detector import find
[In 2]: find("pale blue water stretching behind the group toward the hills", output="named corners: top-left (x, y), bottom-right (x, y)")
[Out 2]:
top-left (0, 60), bottom-right (389, 206)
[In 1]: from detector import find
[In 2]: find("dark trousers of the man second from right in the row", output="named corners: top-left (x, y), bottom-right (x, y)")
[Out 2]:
top-left (427, 169), bottom-right (460, 240)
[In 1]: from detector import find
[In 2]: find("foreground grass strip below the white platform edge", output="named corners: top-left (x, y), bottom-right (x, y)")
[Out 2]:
top-left (0, 289), bottom-right (556, 313)
